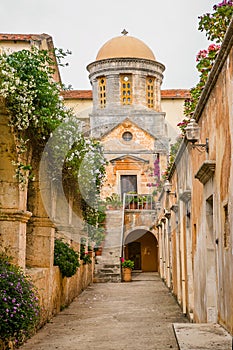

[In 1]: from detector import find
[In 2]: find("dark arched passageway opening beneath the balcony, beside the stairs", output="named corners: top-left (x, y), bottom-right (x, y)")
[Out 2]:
top-left (124, 230), bottom-right (159, 272)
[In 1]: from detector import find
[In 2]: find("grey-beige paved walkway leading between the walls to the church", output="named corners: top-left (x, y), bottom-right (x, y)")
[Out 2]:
top-left (20, 273), bottom-right (188, 350)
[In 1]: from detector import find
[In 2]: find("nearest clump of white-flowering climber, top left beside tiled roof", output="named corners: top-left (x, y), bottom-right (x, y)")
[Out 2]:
top-left (0, 47), bottom-right (70, 185)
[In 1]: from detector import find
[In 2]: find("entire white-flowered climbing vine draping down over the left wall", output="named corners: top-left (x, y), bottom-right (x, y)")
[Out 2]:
top-left (0, 47), bottom-right (106, 246)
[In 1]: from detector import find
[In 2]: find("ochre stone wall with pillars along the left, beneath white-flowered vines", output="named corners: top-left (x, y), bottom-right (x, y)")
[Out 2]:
top-left (0, 99), bottom-right (94, 324)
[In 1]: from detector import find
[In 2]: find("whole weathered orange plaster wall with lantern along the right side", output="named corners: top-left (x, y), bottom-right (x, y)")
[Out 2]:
top-left (157, 25), bottom-right (233, 334)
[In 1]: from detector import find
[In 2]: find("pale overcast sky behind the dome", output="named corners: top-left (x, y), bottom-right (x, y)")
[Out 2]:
top-left (0, 0), bottom-right (217, 90)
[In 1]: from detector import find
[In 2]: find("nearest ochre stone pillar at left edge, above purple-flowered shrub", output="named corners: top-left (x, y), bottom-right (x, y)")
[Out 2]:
top-left (0, 98), bottom-right (31, 268)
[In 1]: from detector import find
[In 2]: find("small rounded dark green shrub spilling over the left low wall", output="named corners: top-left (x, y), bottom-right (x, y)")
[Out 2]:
top-left (54, 239), bottom-right (80, 277)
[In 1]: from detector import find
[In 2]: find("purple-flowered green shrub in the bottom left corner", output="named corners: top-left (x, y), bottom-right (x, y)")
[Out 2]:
top-left (0, 255), bottom-right (40, 346)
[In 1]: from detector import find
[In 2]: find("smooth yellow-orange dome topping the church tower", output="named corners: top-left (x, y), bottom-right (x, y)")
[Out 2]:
top-left (96, 35), bottom-right (155, 61)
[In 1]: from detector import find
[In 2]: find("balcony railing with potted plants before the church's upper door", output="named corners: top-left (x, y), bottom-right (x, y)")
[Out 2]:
top-left (124, 193), bottom-right (155, 210)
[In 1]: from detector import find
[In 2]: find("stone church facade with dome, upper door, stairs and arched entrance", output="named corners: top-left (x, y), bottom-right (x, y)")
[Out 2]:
top-left (80, 33), bottom-right (184, 281)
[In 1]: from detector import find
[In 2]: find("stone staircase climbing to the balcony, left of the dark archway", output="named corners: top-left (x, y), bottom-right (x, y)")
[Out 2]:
top-left (94, 210), bottom-right (124, 282)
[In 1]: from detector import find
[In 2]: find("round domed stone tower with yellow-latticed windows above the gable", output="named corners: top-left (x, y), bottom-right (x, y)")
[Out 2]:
top-left (87, 31), bottom-right (166, 139)
